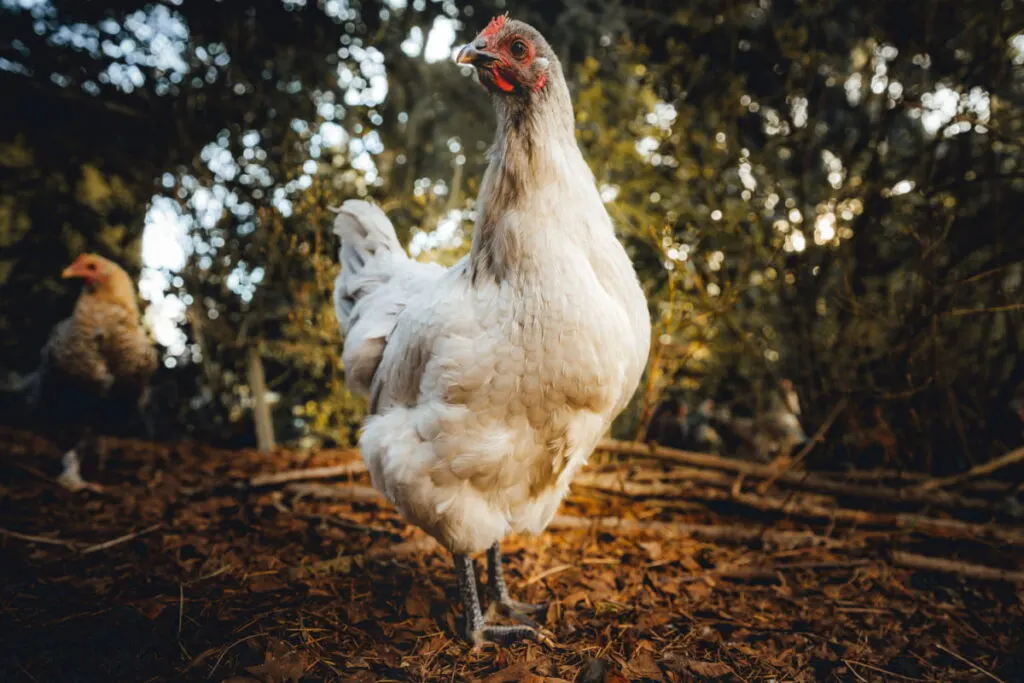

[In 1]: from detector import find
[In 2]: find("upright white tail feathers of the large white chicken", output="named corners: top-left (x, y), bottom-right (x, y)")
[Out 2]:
top-left (334, 200), bottom-right (409, 333)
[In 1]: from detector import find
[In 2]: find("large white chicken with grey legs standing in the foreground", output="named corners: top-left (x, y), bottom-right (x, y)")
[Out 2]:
top-left (334, 16), bottom-right (650, 643)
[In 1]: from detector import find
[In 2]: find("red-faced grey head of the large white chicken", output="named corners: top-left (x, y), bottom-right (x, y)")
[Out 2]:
top-left (456, 15), bottom-right (558, 96)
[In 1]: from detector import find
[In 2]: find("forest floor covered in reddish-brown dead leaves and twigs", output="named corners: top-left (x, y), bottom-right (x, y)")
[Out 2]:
top-left (0, 429), bottom-right (1024, 683)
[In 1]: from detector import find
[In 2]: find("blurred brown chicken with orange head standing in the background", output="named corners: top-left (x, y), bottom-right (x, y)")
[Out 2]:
top-left (25, 254), bottom-right (157, 490)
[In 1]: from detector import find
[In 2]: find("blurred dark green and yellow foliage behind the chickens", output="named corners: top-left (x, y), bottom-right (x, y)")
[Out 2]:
top-left (0, 0), bottom-right (1024, 471)
